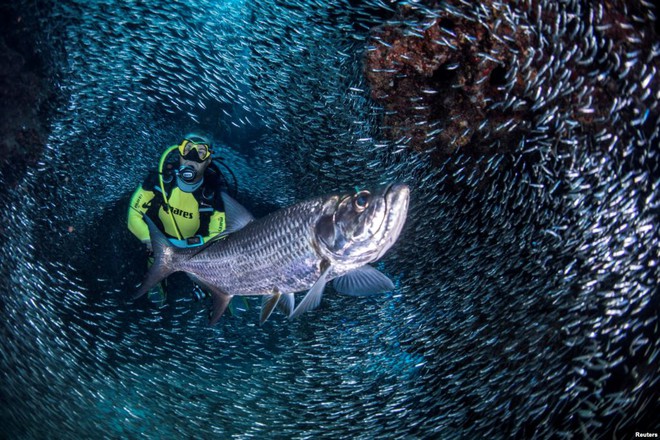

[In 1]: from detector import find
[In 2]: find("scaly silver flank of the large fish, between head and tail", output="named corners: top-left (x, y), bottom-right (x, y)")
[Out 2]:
top-left (182, 199), bottom-right (323, 295)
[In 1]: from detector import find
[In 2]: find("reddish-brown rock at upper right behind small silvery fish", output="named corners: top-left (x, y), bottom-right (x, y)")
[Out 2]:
top-left (364, 1), bottom-right (660, 160)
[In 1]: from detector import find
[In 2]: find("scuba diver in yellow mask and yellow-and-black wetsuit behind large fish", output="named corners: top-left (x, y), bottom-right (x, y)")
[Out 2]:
top-left (128, 133), bottom-right (237, 306)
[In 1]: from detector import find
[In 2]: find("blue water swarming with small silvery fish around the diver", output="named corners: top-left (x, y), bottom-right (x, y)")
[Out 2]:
top-left (0, 0), bottom-right (660, 438)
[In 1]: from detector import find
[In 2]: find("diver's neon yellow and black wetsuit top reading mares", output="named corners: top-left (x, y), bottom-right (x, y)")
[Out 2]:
top-left (128, 159), bottom-right (227, 246)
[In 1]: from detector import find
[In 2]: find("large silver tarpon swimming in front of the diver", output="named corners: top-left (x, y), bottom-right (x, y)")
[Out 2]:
top-left (135, 184), bottom-right (410, 324)
